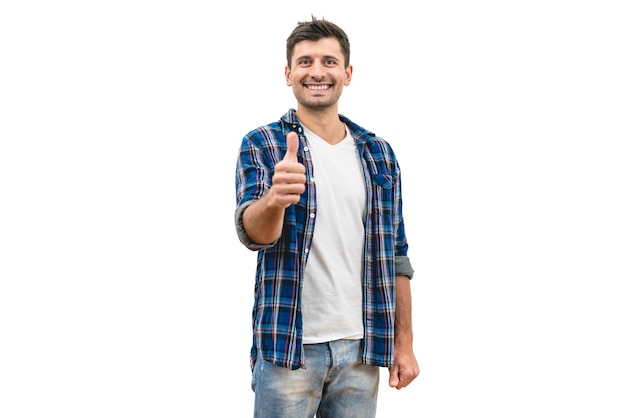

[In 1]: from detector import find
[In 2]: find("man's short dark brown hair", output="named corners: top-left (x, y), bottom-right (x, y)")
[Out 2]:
top-left (287, 16), bottom-right (350, 68)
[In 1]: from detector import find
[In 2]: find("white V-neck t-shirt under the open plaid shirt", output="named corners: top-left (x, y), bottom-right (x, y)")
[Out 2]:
top-left (302, 123), bottom-right (365, 344)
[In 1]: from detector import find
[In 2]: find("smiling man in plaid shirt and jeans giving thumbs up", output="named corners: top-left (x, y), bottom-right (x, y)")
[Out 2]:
top-left (235, 17), bottom-right (419, 418)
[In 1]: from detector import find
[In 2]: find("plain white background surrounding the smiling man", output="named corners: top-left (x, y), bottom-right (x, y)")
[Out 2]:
top-left (0, 0), bottom-right (626, 418)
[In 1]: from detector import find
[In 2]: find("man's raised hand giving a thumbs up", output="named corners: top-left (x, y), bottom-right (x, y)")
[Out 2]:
top-left (270, 132), bottom-right (306, 208)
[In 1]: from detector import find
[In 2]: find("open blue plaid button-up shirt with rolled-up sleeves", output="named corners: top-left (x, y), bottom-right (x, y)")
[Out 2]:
top-left (235, 109), bottom-right (413, 370)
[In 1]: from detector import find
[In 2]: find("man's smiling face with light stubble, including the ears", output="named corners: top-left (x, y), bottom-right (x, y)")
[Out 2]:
top-left (285, 38), bottom-right (352, 110)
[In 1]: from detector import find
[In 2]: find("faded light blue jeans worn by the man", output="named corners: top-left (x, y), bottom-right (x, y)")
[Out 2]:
top-left (252, 340), bottom-right (380, 418)
